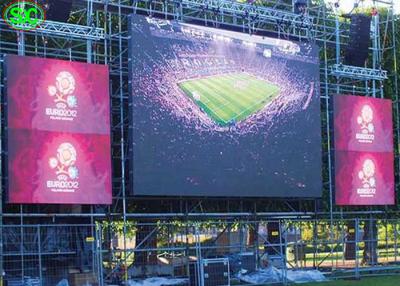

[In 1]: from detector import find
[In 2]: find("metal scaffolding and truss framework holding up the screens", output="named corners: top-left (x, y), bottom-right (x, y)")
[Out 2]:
top-left (0, 0), bottom-right (400, 284)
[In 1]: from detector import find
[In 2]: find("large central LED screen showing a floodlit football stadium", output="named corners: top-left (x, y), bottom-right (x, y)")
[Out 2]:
top-left (130, 15), bottom-right (321, 197)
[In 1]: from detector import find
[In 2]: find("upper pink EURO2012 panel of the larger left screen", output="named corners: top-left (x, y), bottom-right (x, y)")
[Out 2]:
top-left (6, 55), bottom-right (110, 134)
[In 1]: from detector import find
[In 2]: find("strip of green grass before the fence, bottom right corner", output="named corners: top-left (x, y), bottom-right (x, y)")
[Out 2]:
top-left (296, 276), bottom-right (400, 286)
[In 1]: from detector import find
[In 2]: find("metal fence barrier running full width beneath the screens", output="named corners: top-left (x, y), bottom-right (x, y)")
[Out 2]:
top-left (1, 218), bottom-right (400, 286)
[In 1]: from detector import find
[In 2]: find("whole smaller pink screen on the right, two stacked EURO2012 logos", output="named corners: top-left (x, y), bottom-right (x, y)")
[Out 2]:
top-left (334, 95), bottom-right (395, 205)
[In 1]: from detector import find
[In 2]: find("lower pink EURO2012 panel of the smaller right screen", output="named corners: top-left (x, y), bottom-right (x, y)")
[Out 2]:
top-left (335, 151), bottom-right (395, 205)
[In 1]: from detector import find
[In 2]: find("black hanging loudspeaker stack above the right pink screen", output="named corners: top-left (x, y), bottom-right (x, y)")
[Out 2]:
top-left (345, 14), bottom-right (371, 67)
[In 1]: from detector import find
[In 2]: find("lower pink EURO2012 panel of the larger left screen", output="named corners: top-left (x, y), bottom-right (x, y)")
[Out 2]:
top-left (9, 130), bottom-right (111, 204)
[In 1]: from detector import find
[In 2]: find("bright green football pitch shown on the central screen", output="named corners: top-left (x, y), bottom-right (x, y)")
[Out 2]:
top-left (178, 73), bottom-right (280, 126)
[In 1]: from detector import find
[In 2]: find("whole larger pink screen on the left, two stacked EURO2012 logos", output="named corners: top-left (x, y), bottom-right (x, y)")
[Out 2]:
top-left (6, 55), bottom-right (112, 204)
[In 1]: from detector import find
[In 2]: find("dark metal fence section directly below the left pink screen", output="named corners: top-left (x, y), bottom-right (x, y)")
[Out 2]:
top-left (1, 225), bottom-right (101, 285)
